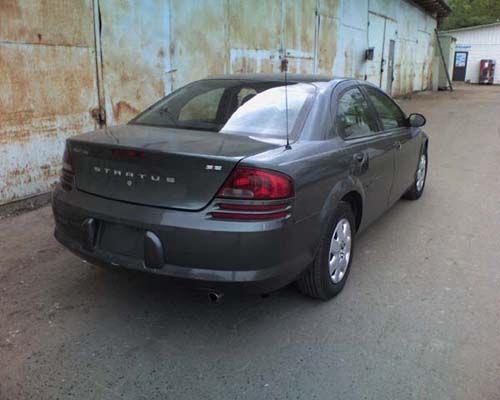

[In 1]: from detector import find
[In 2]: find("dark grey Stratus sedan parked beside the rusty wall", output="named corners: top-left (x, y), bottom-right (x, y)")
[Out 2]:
top-left (53, 74), bottom-right (428, 299)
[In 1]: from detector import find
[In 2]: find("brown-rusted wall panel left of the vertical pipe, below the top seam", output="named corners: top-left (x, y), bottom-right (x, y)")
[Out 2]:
top-left (0, 44), bottom-right (96, 121)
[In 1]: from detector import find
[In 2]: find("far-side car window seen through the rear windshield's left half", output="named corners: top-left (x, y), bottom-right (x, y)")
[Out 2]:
top-left (179, 88), bottom-right (224, 122)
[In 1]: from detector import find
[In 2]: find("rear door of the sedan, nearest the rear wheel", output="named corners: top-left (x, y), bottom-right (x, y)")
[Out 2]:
top-left (334, 85), bottom-right (394, 225)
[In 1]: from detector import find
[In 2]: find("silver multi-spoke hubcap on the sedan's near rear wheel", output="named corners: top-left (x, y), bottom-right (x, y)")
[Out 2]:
top-left (328, 218), bottom-right (352, 283)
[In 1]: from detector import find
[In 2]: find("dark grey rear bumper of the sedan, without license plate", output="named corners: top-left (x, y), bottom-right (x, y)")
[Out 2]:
top-left (52, 188), bottom-right (315, 292)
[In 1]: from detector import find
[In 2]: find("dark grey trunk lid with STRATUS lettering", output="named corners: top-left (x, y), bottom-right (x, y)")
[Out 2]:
top-left (68, 125), bottom-right (278, 211)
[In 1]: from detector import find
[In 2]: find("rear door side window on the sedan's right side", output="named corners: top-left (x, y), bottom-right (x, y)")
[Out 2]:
top-left (335, 88), bottom-right (378, 138)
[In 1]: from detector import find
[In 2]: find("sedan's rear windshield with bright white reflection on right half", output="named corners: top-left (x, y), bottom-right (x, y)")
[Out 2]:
top-left (130, 79), bottom-right (315, 138)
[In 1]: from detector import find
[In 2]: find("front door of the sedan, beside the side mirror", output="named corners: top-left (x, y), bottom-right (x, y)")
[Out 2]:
top-left (364, 85), bottom-right (420, 204)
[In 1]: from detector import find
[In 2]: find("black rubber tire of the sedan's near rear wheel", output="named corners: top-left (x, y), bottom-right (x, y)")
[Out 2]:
top-left (297, 201), bottom-right (356, 300)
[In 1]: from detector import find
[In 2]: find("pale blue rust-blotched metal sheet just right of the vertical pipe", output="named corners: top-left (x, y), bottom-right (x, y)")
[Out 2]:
top-left (97, 0), bottom-right (170, 125)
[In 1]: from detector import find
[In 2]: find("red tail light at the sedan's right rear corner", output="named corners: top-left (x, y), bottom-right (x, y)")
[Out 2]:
top-left (211, 167), bottom-right (295, 221)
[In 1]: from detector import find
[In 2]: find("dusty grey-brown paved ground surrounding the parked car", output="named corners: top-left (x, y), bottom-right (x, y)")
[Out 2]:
top-left (0, 85), bottom-right (500, 400)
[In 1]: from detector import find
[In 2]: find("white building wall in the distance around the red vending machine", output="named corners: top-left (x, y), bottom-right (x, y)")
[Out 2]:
top-left (447, 24), bottom-right (500, 84)
